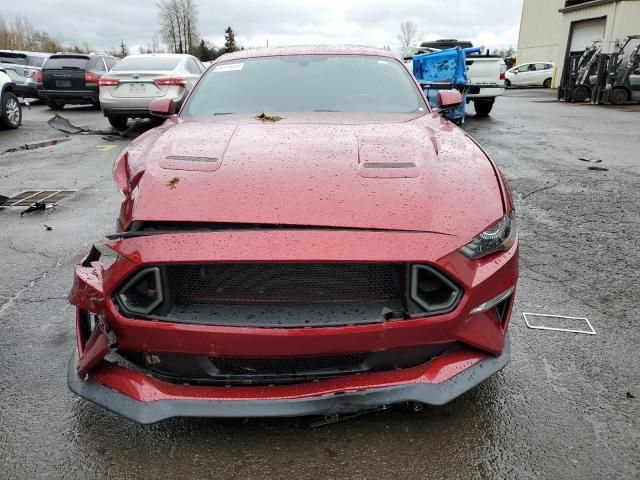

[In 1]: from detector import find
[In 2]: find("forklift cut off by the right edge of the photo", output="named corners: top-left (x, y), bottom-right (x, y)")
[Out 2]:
top-left (600, 34), bottom-right (640, 105)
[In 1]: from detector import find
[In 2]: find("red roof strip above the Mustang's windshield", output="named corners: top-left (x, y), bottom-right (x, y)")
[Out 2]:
top-left (216, 45), bottom-right (398, 63)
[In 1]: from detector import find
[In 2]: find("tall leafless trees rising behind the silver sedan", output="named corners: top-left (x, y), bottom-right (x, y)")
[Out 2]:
top-left (158, 0), bottom-right (199, 53)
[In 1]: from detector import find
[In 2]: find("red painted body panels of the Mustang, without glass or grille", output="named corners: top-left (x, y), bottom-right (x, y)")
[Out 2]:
top-left (69, 48), bottom-right (518, 420)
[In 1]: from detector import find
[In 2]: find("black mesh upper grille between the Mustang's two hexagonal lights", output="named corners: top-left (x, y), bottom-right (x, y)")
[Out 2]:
top-left (167, 263), bottom-right (405, 305)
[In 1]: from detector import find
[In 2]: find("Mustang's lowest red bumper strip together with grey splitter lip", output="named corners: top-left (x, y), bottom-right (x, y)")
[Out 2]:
top-left (67, 338), bottom-right (510, 424)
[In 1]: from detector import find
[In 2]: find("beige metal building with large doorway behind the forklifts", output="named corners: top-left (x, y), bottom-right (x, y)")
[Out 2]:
top-left (517, 0), bottom-right (640, 87)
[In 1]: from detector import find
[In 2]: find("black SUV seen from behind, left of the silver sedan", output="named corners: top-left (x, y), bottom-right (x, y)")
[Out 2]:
top-left (38, 53), bottom-right (117, 110)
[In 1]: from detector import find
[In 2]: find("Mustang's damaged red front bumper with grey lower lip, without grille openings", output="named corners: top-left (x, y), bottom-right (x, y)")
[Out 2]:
top-left (67, 231), bottom-right (518, 423)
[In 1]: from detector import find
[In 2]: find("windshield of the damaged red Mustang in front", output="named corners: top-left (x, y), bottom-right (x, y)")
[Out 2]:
top-left (182, 55), bottom-right (427, 117)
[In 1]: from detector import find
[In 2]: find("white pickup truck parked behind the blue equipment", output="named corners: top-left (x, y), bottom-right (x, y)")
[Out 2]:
top-left (405, 40), bottom-right (507, 117)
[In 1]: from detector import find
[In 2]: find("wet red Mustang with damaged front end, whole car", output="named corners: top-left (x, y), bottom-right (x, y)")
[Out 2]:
top-left (68, 47), bottom-right (518, 423)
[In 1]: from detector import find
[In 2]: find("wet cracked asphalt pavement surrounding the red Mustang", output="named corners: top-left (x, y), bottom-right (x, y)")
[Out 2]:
top-left (0, 90), bottom-right (640, 479)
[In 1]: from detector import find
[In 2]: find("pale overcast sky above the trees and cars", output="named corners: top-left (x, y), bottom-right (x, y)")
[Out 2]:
top-left (0, 0), bottom-right (522, 51)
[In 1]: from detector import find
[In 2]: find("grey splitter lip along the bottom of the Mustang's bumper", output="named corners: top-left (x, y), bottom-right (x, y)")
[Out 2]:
top-left (67, 338), bottom-right (510, 424)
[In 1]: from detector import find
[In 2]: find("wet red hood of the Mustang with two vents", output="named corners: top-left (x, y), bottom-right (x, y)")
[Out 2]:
top-left (116, 114), bottom-right (504, 237)
